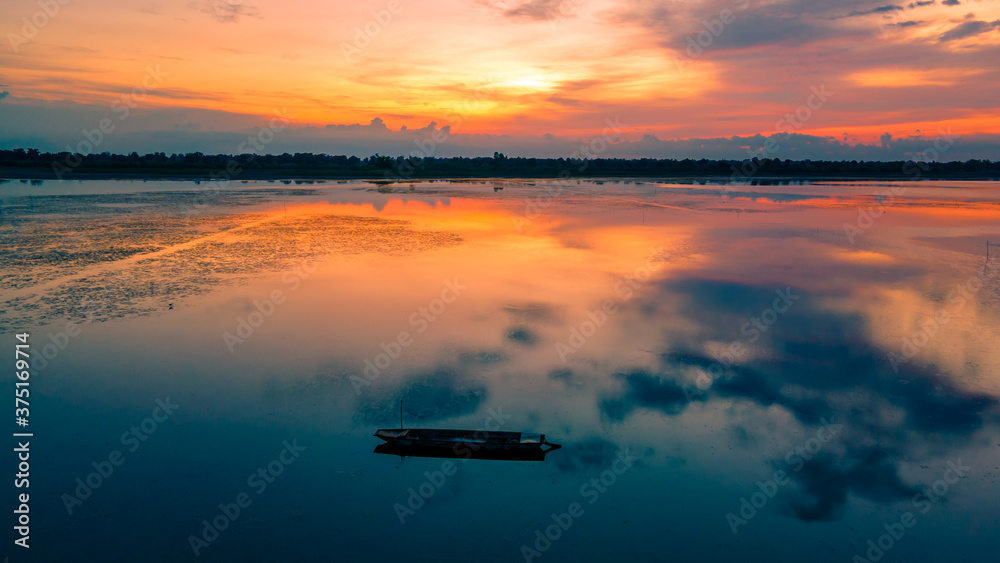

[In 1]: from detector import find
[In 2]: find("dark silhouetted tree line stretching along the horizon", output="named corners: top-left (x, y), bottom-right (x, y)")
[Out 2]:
top-left (0, 149), bottom-right (1000, 181)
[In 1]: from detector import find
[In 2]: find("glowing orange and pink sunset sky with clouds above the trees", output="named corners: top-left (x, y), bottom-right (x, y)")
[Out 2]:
top-left (0, 0), bottom-right (1000, 158)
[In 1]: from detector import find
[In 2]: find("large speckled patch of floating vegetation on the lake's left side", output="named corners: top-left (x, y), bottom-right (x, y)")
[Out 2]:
top-left (0, 189), bottom-right (461, 331)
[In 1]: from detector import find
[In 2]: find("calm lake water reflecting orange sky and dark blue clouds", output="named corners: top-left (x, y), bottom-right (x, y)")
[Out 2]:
top-left (0, 179), bottom-right (1000, 562)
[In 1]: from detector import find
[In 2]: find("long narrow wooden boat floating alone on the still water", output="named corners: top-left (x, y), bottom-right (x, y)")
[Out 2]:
top-left (375, 428), bottom-right (562, 461)
